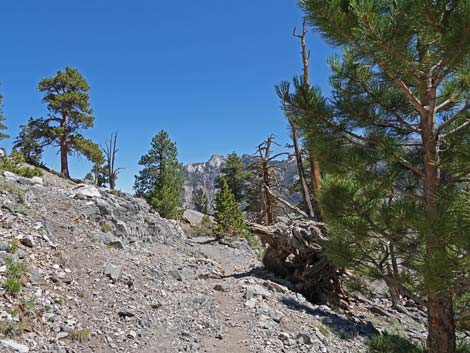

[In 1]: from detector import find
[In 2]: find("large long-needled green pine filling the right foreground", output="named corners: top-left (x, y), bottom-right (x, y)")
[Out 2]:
top-left (290, 0), bottom-right (470, 353)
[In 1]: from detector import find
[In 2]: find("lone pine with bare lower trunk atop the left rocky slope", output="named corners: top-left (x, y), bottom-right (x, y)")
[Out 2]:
top-left (28, 67), bottom-right (99, 178)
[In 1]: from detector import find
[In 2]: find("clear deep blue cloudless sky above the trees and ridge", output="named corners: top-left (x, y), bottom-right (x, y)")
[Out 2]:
top-left (0, 0), bottom-right (333, 191)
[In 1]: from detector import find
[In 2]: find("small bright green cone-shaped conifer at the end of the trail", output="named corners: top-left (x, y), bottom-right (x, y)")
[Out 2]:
top-left (214, 177), bottom-right (247, 237)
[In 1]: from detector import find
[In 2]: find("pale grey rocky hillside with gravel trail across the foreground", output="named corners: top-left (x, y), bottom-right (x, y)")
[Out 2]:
top-left (0, 166), bottom-right (425, 353)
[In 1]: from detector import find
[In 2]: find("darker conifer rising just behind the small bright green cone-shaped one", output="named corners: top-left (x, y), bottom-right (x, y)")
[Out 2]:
top-left (221, 152), bottom-right (250, 203)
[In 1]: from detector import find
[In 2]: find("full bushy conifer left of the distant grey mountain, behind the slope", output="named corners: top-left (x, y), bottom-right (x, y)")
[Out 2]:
top-left (134, 130), bottom-right (184, 218)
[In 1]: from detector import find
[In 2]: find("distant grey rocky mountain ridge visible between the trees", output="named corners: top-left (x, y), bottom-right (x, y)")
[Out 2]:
top-left (183, 154), bottom-right (297, 210)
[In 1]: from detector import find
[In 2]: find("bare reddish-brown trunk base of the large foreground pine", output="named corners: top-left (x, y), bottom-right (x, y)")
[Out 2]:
top-left (428, 295), bottom-right (456, 353)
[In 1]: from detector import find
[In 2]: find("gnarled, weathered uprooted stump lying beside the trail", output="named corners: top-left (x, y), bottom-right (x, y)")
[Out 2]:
top-left (250, 220), bottom-right (342, 303)
